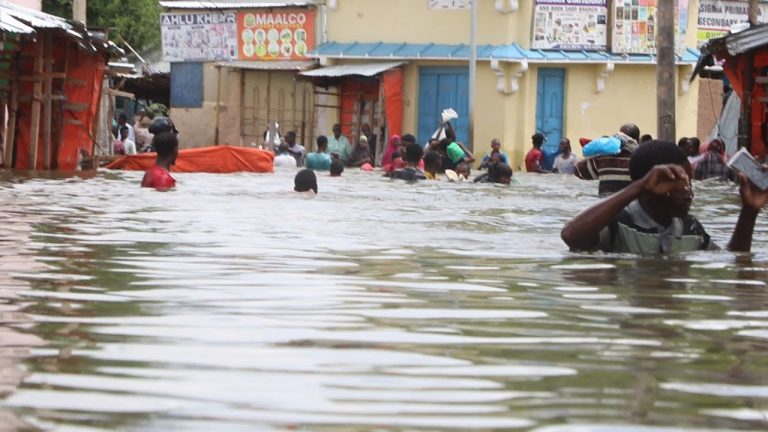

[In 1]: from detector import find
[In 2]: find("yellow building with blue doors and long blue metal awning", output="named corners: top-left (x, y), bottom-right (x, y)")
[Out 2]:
top-left (302, 0), bottom-right (698, 168)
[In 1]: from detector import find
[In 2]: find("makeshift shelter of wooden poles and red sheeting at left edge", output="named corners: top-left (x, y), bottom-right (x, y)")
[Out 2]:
top-left (0, 0), bottom-right (120, 170)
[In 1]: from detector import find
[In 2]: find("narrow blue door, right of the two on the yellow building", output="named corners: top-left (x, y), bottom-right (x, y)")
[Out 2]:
top-left (536, 68), bottom-right (565, 169)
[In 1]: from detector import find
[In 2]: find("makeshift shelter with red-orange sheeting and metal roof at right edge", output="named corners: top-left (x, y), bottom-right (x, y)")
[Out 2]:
top-left (697, 24), bottom-right (768, 159)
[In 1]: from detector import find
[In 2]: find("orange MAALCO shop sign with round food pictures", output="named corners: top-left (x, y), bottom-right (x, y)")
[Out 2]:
top-left (237, 9), bottom-right (315, 60)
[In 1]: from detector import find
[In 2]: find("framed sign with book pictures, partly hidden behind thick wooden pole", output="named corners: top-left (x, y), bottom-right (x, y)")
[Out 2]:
top-left (611, 0), bottom-right (688, 55)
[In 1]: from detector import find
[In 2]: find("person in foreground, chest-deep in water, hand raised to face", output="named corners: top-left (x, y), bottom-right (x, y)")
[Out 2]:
top-left (561, 141), bottom-right (768, 254)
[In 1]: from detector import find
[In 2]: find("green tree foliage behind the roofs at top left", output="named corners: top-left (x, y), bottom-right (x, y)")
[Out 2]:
top-left (43, 0), bottom-right (160, 50)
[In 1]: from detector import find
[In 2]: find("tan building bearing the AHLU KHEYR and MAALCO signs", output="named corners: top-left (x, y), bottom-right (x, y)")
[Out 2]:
top-left (160, 0), bottom-right (321, 148)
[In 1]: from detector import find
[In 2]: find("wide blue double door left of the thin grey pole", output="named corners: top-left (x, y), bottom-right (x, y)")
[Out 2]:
top-left (416, 67), bottom-right (471, 146)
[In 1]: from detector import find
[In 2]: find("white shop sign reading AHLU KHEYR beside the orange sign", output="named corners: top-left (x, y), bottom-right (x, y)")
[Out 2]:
top-left (160, 12), bottom-right (237, 62)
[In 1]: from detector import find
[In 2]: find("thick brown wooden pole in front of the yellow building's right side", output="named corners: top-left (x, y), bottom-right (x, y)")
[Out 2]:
top-left (656, 1), bottom-right (677, 142)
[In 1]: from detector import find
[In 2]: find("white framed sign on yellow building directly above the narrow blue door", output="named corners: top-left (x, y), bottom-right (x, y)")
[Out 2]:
top-left (531, 0), bottom-right (608, 51)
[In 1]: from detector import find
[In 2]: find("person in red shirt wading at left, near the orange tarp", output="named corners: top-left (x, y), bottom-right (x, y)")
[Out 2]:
top-left (141, 117), bottom-right (179, 191)
